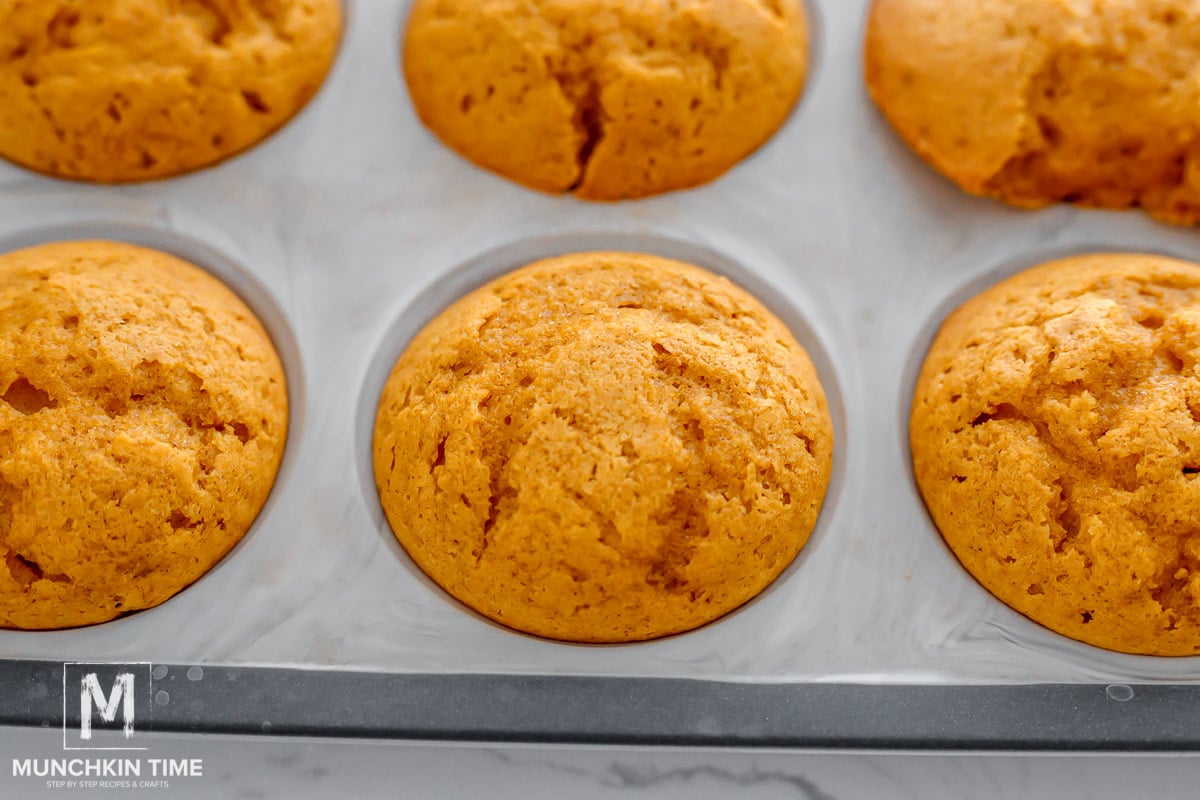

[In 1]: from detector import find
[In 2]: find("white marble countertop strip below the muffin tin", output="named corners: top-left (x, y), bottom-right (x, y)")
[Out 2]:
top-left (0, 728), bottom-right (1200, 800)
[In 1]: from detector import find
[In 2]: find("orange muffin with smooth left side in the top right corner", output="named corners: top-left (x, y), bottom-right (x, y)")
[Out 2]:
top-left (865, 0), bottom-right (1200, 224)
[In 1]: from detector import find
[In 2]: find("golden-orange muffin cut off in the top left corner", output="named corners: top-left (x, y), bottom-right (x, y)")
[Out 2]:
top-left (0, 0), bottom-right (342, 184)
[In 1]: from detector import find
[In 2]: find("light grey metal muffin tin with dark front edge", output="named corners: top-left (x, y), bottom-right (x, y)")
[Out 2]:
top-left (0, 0), bottom-right (1200, 750)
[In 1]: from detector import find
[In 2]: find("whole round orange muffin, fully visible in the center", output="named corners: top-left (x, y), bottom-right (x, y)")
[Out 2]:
top-left (373, 253), bottom-right (833, 642)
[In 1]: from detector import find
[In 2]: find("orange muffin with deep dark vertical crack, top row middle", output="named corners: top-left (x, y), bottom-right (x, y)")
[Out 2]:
top-left (403, 0), bottom-right (808, 200)
